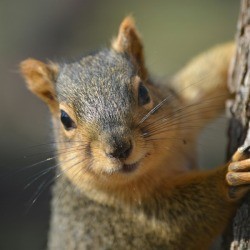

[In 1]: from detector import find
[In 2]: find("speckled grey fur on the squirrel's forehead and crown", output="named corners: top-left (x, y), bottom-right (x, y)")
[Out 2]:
top-left (56, 49), bottom-right (135, 131)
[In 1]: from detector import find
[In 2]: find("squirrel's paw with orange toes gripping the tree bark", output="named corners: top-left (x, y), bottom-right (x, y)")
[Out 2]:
top-left (226, 146), bottom-right (250, 199)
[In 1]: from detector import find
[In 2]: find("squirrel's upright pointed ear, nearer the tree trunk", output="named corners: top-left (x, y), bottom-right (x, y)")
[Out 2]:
top-left (112, 16), bottom-right (147, 79)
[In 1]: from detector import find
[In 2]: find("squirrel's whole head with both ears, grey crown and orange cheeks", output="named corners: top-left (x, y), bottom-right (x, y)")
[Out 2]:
top-left (20, 17), bottom-right (180, 197)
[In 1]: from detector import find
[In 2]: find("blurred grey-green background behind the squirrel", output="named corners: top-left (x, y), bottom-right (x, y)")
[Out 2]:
top-left (0, 0), bottom-right (239, 250)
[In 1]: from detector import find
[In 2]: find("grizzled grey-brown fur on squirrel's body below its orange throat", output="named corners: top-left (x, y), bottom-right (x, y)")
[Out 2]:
top-left (49, 174), bottom-right (174, 250)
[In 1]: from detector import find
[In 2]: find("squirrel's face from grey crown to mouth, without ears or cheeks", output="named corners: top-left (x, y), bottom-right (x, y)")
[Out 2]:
top-left (56, 47), bottom-right (153, 175)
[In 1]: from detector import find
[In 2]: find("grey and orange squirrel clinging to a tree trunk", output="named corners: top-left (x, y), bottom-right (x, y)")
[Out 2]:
top-left (20, 16), bottom-right (250, 250)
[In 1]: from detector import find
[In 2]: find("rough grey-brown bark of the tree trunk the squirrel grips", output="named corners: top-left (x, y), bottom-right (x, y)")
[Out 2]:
top-left (223, 0), bottom-right (250, 250)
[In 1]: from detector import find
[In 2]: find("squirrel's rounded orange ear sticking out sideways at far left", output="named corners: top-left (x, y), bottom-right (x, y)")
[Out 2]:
top-left (20, 58), bottom-right (59, 113)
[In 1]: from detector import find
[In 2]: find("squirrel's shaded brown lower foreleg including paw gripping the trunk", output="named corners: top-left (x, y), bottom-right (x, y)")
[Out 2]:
top-left (151, 148), bottom-right (250, 249)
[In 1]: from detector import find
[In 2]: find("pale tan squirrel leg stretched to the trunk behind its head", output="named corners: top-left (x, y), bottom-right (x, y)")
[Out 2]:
top-left (171, 42), bottom-right (235, 131)
